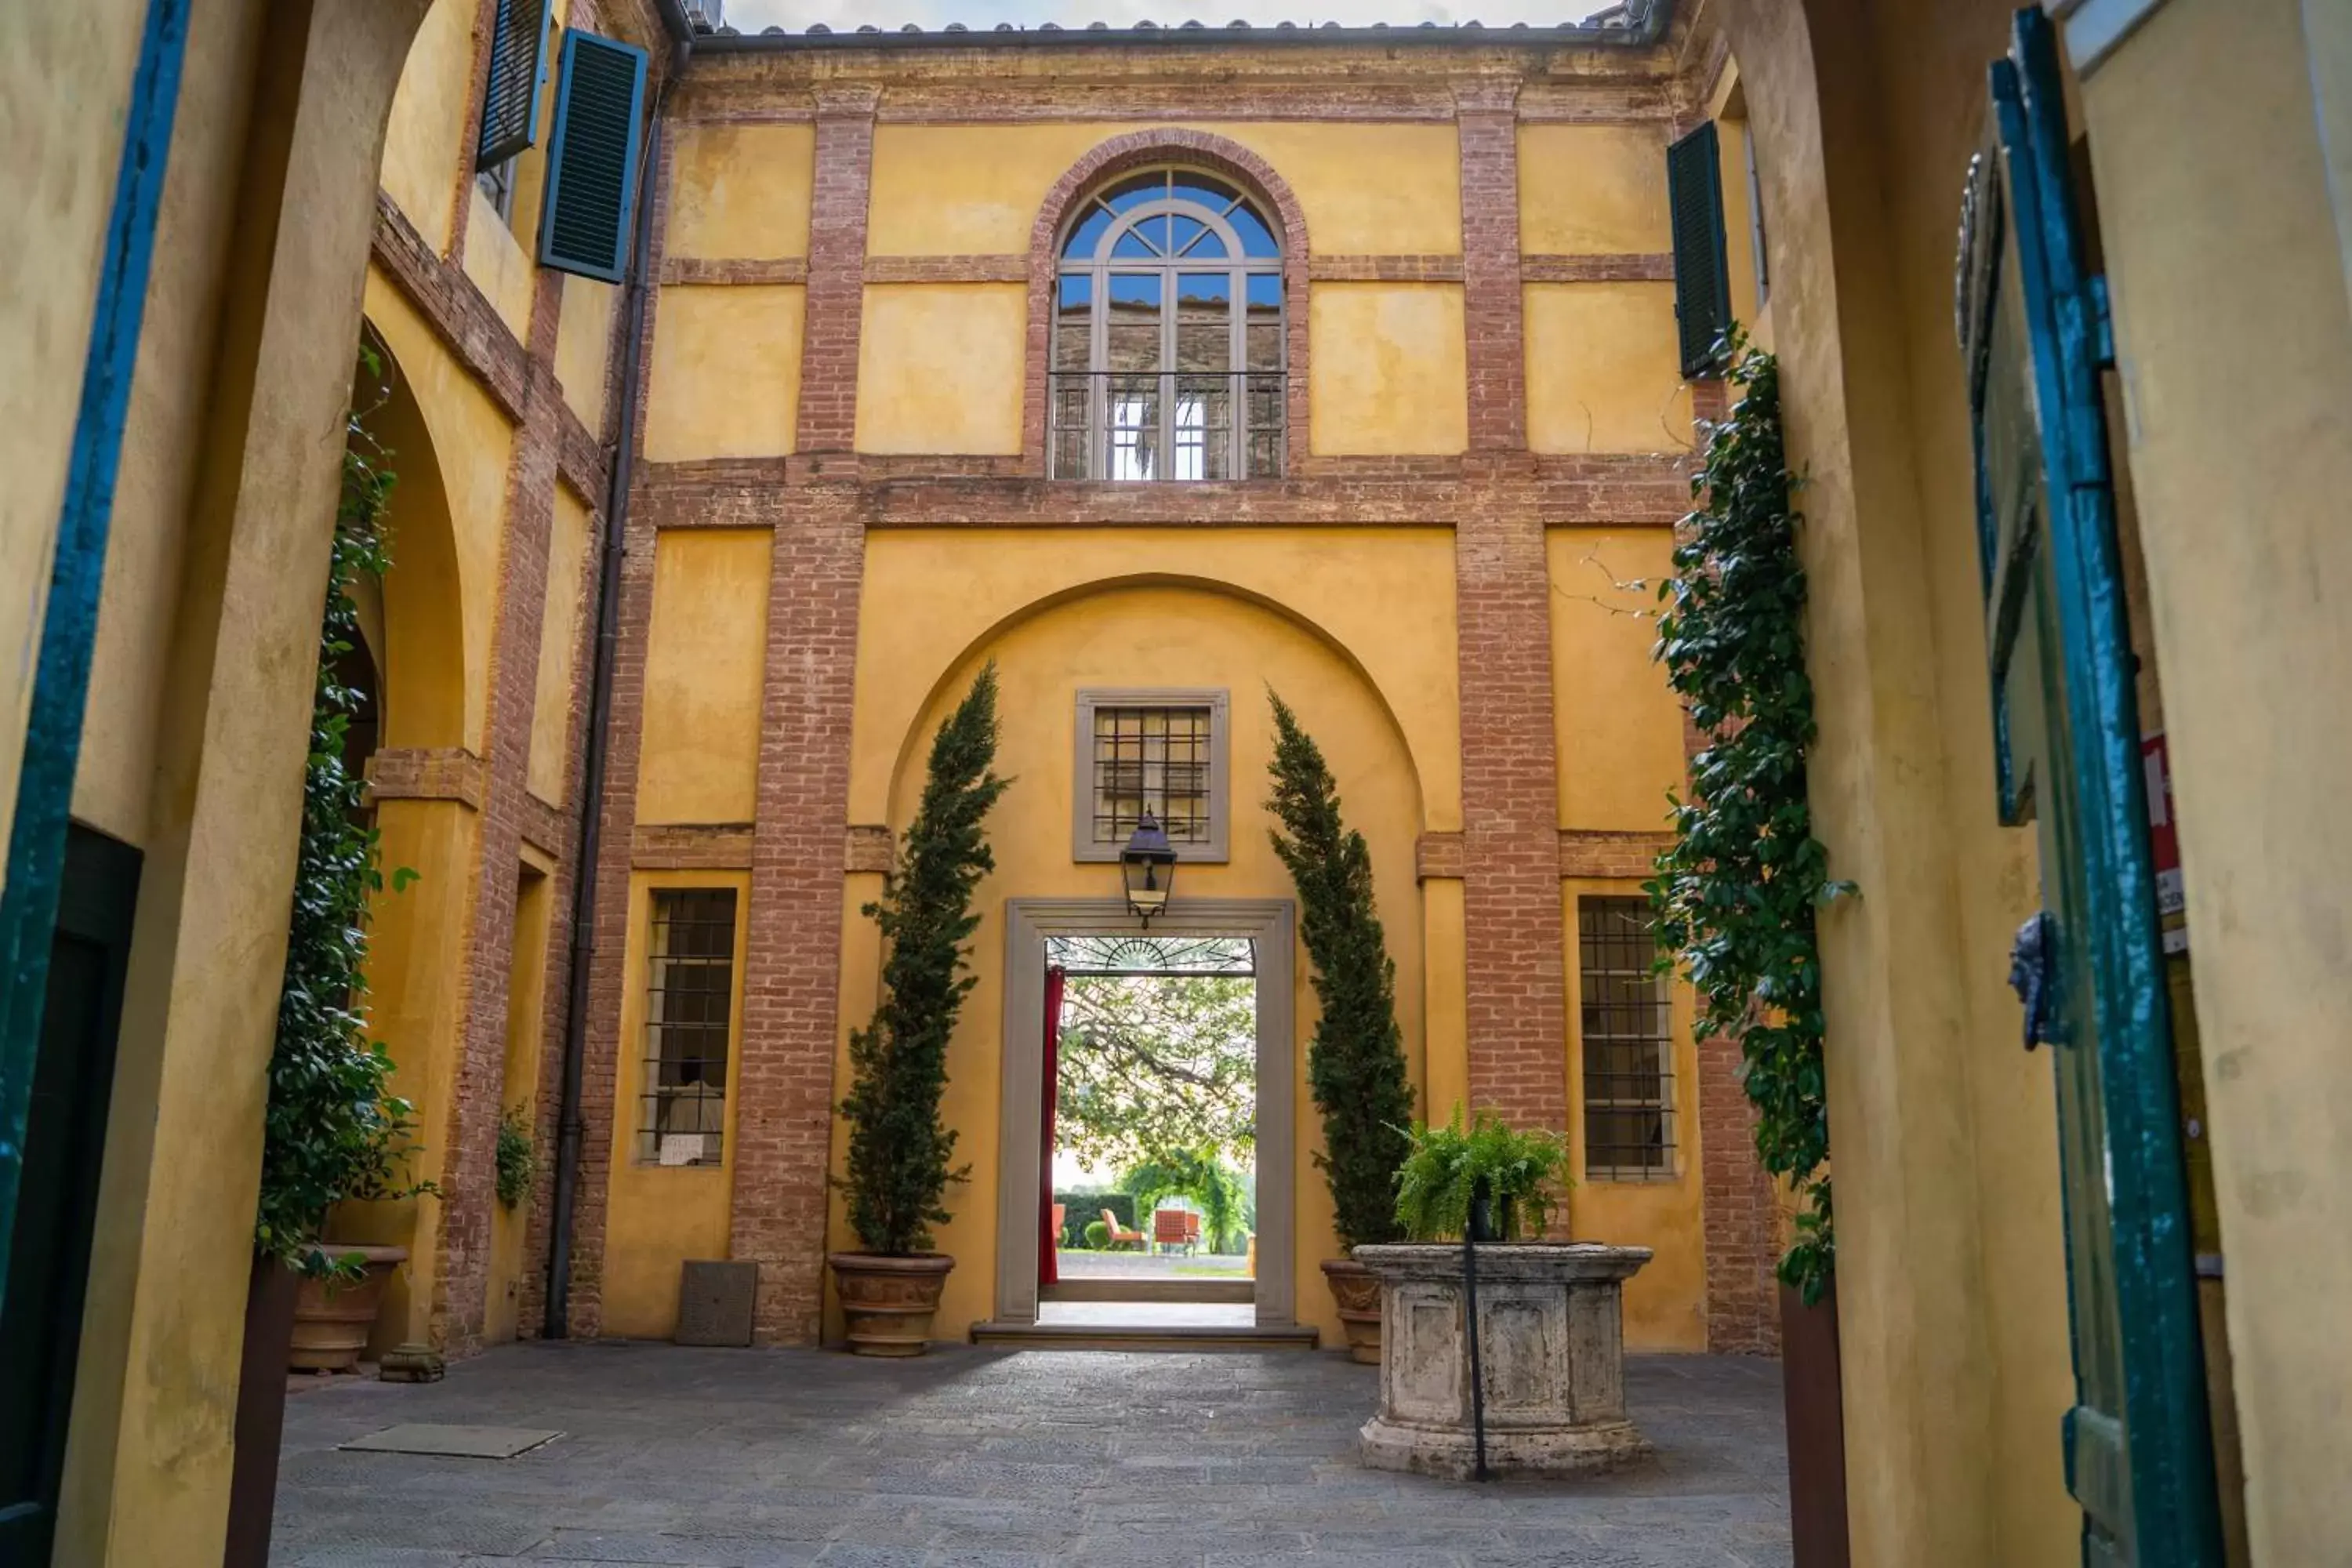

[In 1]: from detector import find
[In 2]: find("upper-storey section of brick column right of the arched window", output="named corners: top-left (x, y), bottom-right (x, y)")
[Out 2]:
top-left (1454, 82), bottom-right (1526, 452)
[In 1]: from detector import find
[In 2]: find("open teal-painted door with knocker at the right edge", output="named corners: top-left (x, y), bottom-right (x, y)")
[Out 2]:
top-left (1959, 9), bottom-right (2223, 1568)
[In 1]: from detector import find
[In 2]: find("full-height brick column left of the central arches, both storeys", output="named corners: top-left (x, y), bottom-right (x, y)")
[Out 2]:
top-left (731, 87), bottom-right (880, 1345)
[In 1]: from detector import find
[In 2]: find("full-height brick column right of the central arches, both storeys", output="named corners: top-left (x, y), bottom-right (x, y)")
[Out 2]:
top-left (1454, 82), bottom-right (1569, 1131)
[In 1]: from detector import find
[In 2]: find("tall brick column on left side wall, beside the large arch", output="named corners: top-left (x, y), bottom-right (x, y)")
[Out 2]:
top-left (430, 273), bottom-right (562, 1354)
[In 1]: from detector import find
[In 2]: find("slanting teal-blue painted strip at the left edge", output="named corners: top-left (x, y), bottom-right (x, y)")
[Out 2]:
top-left (0, 0), bottom-right (191, 1307)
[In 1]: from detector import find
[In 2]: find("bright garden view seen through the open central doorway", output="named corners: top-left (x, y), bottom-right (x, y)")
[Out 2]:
top-left (1037, 931), bottom-right (1258, 1328)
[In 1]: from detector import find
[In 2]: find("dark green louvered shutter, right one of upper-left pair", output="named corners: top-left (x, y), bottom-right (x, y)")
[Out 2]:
top-left (539, 28), bottom-right (644, 282)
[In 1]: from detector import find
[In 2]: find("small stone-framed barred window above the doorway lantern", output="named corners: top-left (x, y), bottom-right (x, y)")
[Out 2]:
top-left (1073, 689), bottom-right (1228, 862)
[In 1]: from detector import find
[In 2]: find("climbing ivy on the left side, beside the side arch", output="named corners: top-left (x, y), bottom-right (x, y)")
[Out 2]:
top-left (254, 346), bottom-right (433, 1274)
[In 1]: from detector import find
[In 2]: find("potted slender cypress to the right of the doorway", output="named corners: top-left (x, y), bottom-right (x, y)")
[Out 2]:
top-left (1265, 691), bottom-right (1414, 1366)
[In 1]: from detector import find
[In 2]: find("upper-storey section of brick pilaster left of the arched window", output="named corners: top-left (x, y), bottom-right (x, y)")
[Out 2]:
top-left (795, 85), bottom-right (882, 454)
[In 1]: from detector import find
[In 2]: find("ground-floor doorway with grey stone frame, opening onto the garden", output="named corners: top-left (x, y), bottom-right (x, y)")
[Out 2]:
top-left (995, 898), bottom-right (1296, 1328)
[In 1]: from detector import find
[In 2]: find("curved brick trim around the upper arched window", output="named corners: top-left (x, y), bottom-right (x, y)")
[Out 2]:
top-left (1021, 127), bottom-right (1308, 480)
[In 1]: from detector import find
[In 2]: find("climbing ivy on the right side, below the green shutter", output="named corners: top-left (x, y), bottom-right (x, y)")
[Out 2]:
top-left (1649, 334), bottom-right (1851, 1305)
